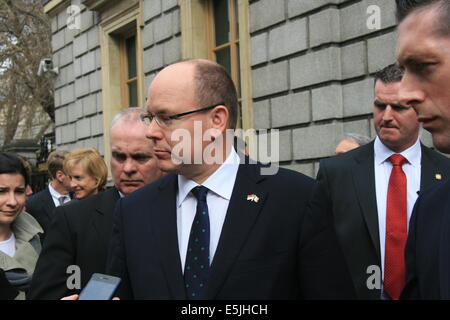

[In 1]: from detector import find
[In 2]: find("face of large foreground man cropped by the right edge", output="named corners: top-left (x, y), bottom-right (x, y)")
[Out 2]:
top-left (397, 8), bottom-right (450, 153)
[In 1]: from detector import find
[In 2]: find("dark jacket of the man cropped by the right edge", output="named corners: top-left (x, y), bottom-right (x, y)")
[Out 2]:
top-left (401, 180), bottom-right (450, 300)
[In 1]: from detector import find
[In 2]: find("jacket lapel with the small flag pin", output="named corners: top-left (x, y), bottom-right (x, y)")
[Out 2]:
top-left (205, 164), bottom-right (268, 299)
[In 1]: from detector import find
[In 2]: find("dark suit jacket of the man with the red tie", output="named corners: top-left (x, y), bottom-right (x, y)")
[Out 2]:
top-left (301, 142), bottom-right (450, 299)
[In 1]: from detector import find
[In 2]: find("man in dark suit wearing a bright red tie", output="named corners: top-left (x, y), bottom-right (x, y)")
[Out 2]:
top-left (300, 65), bottom-right (450, 299)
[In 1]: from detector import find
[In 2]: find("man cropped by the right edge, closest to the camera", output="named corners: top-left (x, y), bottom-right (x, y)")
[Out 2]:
top-left (396, 0), bottom-right (450, 299)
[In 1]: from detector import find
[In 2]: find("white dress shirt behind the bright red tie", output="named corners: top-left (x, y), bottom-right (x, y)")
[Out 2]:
top-left (374, 137), bottom-right (422, 280)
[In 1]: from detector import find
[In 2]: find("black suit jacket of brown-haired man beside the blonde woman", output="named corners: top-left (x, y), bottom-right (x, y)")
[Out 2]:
top-left (25, 186), bottom-right (55, 243)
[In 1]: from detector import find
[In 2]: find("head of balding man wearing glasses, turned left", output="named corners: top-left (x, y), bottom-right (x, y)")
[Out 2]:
top-left (143, 59), bottom-right (237, 178)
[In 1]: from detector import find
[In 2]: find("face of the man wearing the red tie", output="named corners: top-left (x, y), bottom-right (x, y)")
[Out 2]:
top-left (373, 80), bottom-right (419, 152)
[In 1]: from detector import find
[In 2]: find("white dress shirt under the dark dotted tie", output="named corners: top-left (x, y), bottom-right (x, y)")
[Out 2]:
top-left (177, 148), bottom-right (240, 272)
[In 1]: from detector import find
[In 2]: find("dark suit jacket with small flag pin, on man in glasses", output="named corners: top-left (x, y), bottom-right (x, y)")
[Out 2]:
top-left (108, 164), bottom-right (314, 300)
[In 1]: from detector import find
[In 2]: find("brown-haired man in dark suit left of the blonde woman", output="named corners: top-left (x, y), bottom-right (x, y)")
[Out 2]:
top-left (25, 150), bottom-right (71, 242)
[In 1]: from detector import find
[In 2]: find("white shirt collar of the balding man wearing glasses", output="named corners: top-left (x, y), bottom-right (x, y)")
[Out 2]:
top-left (177, 148), bottom-right (240, 207)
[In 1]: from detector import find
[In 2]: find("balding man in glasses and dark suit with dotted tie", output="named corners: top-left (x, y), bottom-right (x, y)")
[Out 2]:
top-left (108, 60), bottom-right (314, 299)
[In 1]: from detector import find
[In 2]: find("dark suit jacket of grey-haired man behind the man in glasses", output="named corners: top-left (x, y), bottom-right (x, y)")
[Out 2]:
top-left (28, 188), bottom-right (119, 299)
